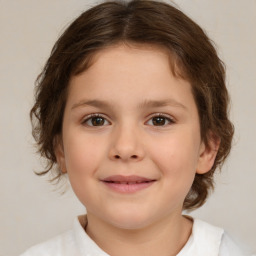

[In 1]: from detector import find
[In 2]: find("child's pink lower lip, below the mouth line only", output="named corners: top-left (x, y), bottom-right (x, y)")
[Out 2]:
top-left (103, 181), bottom-right (155, 194)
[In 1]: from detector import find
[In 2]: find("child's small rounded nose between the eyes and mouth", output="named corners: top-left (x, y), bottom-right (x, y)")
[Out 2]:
top-left (109, 126), bottom-right (145, 161)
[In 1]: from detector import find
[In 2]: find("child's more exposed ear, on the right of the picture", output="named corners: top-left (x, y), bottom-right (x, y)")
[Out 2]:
top-left (196, 132), bottom-right (220, 174)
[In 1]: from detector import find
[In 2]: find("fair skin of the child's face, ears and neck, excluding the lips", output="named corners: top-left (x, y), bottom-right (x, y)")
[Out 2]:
top-left (56, 44), bottom-right (218, 256)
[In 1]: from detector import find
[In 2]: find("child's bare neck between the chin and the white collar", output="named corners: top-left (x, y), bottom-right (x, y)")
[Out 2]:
top-left (86, 213), bottom-right (192, 256)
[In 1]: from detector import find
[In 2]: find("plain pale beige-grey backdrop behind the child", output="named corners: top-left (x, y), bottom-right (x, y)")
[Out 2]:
top-left (0, 0), bottom-right (256, 256)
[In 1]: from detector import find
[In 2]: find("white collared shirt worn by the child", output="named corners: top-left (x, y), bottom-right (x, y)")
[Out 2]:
top-left (20, 216), bottom-right (252, 256)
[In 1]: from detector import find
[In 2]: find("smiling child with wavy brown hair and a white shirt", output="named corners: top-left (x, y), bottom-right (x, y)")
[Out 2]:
top-left (23, 0), bottom-right (252, 256)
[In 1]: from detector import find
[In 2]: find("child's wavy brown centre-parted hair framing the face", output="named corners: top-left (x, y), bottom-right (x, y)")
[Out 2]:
top-left (30, 0), bottom-right (234, 209)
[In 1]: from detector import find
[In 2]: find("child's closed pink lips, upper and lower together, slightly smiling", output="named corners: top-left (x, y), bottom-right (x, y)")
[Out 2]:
top-left (101, 175), bottom-right (156, 194)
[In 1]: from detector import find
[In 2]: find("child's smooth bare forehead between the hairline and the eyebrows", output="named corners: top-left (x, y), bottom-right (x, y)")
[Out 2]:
top-left (66, 44), bottom-right (196, 113)
